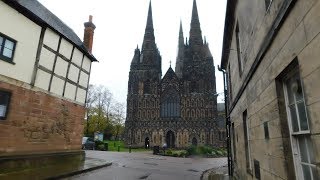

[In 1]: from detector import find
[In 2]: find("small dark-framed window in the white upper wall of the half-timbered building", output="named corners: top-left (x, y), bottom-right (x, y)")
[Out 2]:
top-left (0, 33), bottom-right (16, 62)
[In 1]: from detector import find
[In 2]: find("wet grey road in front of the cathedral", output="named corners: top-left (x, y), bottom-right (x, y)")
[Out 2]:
top-left (68, 151), bottom-right (227, 180)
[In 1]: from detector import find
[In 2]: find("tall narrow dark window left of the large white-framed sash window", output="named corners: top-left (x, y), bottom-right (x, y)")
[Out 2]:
top-left (242, 110), bottom-right (252, 173)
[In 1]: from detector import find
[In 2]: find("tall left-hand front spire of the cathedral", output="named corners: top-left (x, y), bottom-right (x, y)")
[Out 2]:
top-left (141, 0), bottom-right (156, 51)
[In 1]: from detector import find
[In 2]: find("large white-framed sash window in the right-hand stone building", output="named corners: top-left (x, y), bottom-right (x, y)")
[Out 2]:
top-left (283, 68), bottom-right (318, 180)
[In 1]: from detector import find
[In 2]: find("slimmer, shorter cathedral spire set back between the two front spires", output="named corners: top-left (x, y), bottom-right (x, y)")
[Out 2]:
top-left (175, 20), bottom-right (184, 78)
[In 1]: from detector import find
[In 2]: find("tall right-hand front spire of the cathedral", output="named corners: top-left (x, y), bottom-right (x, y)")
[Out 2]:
top-left (189, 0), bottom-right (203, 46)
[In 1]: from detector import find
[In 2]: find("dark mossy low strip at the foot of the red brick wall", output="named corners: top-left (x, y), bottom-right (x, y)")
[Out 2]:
top-left (0, 151), bottom-right (85, 179)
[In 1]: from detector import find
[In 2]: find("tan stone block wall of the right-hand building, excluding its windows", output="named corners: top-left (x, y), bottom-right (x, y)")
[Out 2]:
top-left (224, 0), bottom-right (320, 180)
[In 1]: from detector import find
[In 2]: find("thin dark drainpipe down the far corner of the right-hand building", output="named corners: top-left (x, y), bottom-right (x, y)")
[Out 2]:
top-left (218, 65), bottom-right (233, 176)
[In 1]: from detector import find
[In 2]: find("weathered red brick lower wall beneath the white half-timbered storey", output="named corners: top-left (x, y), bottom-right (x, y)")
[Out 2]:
top-left (0, 82), bottom-right (85, 155)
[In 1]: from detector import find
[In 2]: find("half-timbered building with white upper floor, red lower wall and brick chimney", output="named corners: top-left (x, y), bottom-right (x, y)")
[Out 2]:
top-left (0, 0), bottom-right (97, 179)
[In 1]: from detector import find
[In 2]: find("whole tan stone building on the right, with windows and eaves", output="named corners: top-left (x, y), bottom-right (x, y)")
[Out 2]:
top-left (221, 0), bottom-right (320, 180)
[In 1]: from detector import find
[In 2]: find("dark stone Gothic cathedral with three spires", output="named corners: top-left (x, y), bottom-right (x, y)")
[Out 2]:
top-left (125, 0), bottom-right (224, 148)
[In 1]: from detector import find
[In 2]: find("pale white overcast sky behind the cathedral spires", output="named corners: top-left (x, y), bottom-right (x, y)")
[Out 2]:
top-left (39, 0), bottom-right (226, 103)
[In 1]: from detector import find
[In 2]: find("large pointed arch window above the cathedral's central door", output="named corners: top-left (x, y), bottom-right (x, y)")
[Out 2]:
top-left (161, 89), bottom-right (180, 117)
